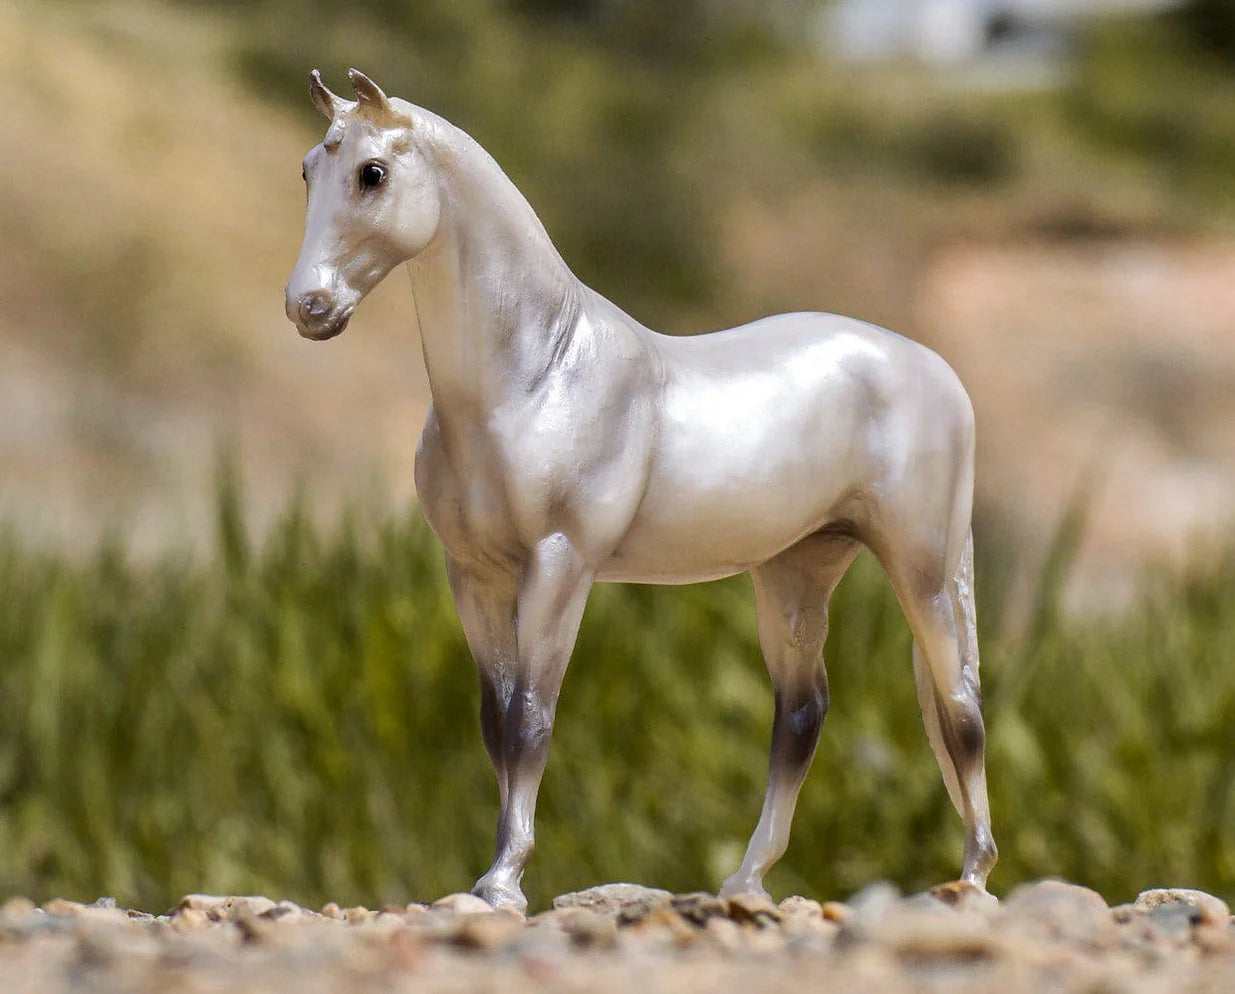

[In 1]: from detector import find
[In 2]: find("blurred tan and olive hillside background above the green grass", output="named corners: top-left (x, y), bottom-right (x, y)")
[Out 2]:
top-left (0, 0), bottom-right (1235, 604)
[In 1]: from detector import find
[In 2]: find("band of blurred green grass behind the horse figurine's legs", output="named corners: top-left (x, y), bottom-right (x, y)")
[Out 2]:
top-left (0, 488), bottom-right (1235, 909)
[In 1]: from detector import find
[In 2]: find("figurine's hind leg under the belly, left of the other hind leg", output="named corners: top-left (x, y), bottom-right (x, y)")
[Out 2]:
top-left (720, 535), bottom-right (858, 898)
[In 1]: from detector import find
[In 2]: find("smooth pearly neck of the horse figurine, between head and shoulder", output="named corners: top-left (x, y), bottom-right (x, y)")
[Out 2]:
top-left (409, 132), bottom-right (582, 417)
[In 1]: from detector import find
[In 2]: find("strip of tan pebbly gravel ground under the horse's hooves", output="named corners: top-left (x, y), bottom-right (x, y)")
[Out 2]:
top-left (0, 880), bottom-right (1235, 994)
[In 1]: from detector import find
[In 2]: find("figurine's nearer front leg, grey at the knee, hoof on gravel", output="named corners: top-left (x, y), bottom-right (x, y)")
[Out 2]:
top-left (472, 533), bottom-right (593, 911)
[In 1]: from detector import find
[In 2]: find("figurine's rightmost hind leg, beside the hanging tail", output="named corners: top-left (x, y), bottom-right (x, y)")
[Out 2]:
top-left (885, 533), bottom-right (998, 889)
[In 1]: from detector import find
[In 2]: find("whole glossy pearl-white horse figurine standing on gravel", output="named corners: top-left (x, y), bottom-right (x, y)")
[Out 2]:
top-left (287, 69), bottom-right (997, 911)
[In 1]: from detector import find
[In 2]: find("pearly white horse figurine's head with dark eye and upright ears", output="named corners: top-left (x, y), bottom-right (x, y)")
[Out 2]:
top-left (285, 69), bottom-right (441, 341)
